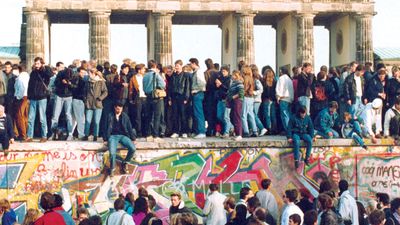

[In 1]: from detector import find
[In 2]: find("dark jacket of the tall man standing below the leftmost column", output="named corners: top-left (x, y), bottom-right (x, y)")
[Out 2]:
top-left (28, 66), bottom-right (52, 100)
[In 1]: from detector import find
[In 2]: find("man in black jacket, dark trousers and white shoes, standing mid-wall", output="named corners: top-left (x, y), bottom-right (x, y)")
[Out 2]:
top-left (168, 60), bottom-right (190, 138)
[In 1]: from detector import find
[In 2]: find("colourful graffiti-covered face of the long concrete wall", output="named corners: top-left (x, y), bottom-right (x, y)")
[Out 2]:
top-left (0, 145), bottom-right (400, 221)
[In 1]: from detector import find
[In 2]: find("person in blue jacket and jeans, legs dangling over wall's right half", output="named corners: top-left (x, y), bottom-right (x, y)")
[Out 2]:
top-left (287, 105), bottom-right (315, 169)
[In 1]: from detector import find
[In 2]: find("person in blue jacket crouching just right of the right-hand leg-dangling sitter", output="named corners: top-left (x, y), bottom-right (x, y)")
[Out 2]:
top-left (314, 101), bottom-right (339, 138)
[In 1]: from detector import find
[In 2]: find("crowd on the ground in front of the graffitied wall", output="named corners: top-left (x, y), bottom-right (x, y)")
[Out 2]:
top-left (0, 179), bottom-right (400, 225)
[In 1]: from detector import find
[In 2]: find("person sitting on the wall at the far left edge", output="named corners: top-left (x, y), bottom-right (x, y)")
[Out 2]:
top-left (0, 105), bottom-right (14, 154)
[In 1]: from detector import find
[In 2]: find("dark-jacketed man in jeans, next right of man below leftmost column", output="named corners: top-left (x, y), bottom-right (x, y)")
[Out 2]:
top-left (51, 69), bottom-right (73, 141)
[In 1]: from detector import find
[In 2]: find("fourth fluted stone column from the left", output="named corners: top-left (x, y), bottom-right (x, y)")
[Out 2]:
top-left (236, 12), bottom-right (255, 65)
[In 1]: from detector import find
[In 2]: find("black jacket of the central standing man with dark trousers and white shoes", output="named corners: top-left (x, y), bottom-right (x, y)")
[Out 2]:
top-left (168, 72), bottom-right (191, 101)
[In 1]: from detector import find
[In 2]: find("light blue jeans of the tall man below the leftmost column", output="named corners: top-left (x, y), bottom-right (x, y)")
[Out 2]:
top-left (27, 98), bottom-right (47, 138)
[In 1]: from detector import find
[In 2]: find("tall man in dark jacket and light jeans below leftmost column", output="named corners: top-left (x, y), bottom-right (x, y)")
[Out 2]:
top-left (25, 57), bottom-right (52, 142)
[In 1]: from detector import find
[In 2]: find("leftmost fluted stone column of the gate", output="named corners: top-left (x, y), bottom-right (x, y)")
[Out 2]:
top-left (25, 11), bottom-right (46, 71)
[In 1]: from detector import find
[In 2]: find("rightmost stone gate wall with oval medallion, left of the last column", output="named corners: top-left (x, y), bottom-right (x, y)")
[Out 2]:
top-left (329, 15), bottom-right (356, 66)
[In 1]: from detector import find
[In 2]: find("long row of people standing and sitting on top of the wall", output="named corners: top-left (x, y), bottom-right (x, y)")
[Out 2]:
top-left (0, 57), bottom-right (400, 171)
